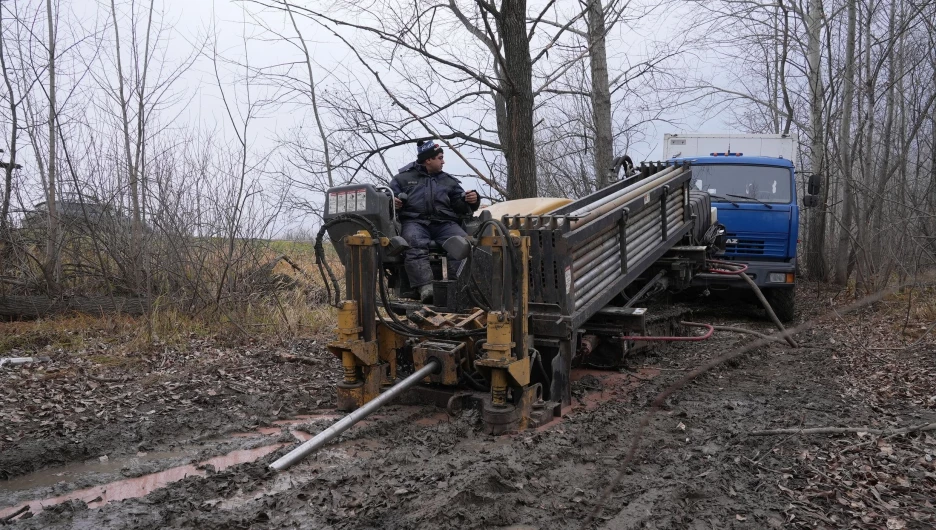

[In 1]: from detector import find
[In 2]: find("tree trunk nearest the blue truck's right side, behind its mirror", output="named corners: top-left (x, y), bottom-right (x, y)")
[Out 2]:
top-left (806, 0), bottom-right (829, 281)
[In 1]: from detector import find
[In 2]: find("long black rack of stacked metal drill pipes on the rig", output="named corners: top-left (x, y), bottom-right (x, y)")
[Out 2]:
top-left (503, 163), bottom-right (711, 405)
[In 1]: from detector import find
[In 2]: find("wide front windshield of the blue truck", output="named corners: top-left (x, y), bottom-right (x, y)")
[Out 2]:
top-left (692, 164), bottom-right (792, 204)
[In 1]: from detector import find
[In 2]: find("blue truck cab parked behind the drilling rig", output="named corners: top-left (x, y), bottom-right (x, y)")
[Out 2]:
top-left (674, 153), bottom-right (799, 322)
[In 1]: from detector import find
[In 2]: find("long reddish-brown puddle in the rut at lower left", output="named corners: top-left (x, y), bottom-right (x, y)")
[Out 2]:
top-left (0, 443), bottom-right (287, 518)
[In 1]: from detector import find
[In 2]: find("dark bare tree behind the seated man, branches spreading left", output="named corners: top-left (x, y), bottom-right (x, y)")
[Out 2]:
top-left (243, 0), bottom-right (616, 197)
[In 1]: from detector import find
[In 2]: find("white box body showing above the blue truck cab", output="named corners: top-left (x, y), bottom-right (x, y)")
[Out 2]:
top-left (663, 133), bottom-right (798, 164)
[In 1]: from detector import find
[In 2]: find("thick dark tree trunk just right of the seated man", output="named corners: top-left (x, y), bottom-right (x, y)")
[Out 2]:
top-left (500, 0), bottom-right (537, 199)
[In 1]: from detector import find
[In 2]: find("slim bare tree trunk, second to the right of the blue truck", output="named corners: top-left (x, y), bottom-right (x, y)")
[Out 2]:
top-left (835, 0), bottom-right (858, 285)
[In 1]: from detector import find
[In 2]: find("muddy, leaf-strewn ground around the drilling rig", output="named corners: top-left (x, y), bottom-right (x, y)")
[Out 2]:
top-left (0, 286), bottom-right (936, 529)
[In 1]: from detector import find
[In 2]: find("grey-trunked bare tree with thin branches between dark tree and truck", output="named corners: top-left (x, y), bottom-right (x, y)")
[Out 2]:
top-left (530, 0), bottom-right (685, 194)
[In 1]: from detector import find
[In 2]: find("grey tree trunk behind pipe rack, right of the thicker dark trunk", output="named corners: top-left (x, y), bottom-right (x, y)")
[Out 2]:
top-left (588, 0), bottom-right (614, 189)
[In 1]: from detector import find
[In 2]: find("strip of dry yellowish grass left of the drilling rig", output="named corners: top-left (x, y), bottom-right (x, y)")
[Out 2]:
top-left (0, 242), bottom-right (344, 354)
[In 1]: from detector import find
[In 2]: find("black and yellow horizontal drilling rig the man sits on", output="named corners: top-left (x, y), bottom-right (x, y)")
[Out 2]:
top-left (274, 163), bottom-right (724, 468)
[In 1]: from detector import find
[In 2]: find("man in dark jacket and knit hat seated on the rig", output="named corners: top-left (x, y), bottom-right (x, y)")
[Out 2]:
top-left (390, 141), bottom-right (480, 303)
